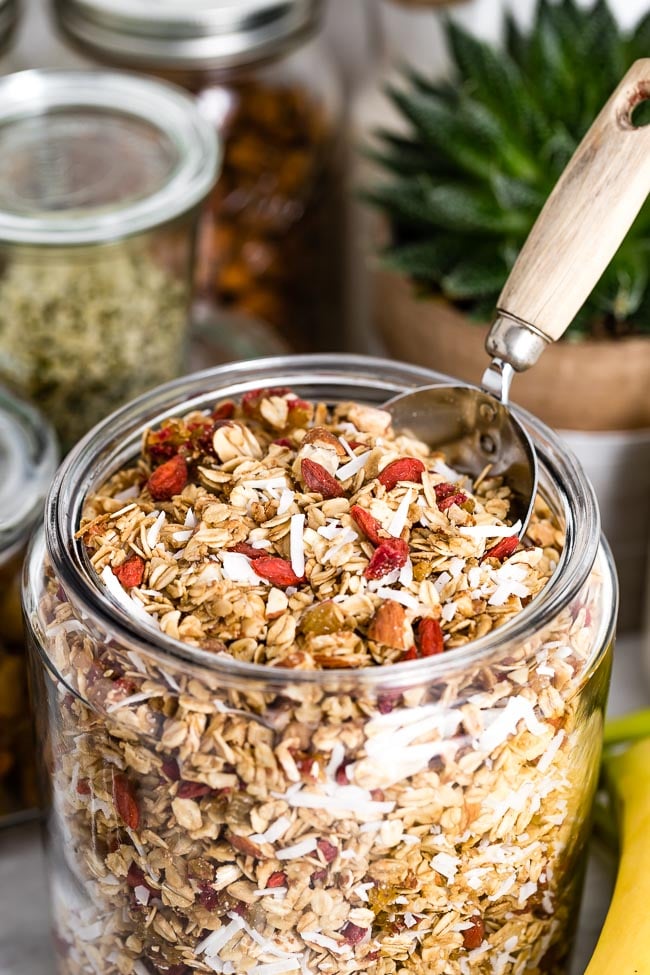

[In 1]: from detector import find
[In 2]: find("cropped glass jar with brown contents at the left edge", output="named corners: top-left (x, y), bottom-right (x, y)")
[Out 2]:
top-left (0, 386), bottom-right (57, 825)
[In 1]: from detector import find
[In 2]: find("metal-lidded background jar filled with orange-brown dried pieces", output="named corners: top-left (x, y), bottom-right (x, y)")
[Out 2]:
top-left (55, 0), bottom-right (343, 350)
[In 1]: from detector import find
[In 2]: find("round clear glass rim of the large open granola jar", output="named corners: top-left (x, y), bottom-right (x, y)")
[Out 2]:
top-left (45, 354), bottom-right (616, 689)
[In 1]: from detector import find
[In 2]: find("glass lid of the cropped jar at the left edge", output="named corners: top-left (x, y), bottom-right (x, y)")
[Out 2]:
top-left (0, 386), bottom-right (58, 564)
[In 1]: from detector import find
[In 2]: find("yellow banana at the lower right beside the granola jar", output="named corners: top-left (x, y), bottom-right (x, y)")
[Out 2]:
top-left (585, 738), bottom-right (650, 975)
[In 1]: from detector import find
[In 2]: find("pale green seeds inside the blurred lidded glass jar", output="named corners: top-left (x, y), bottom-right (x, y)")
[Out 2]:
top-left (0, 250), bottom-right (189, 449)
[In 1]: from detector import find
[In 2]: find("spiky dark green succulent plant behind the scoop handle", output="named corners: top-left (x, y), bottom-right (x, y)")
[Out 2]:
top-left (366, 0), bottom-right (650, 339)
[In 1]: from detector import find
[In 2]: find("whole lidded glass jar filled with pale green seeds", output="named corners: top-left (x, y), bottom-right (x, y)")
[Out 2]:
top-left (0, 71), bottom-right (217, 448)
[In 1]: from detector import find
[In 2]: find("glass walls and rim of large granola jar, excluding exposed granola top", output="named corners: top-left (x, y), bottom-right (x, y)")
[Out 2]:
top-left (24, 356), bottom-right (616, 975)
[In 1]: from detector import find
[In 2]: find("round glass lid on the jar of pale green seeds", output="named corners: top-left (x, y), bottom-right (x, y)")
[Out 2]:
top-left (0, 70), bottom-right (219, 245)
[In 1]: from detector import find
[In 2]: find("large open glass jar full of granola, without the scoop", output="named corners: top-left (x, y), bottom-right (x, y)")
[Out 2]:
top-left (24, 356), bottom-right (616, 975)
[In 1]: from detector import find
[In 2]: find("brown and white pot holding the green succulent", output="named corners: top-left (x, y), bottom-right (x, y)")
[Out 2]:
top-left (374, 271), bottom-right (650, 630)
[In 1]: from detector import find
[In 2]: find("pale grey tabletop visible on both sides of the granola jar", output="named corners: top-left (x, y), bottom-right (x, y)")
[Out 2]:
top-left (0, 637), bottom-right (650, 975)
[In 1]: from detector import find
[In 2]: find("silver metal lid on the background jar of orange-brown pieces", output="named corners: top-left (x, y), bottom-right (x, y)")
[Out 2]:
top-left (55, 0), bottom-right (323, 67)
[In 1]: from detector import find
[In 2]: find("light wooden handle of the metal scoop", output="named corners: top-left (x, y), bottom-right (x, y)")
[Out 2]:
top-left (497, 58), bottom-right (650, 340)
